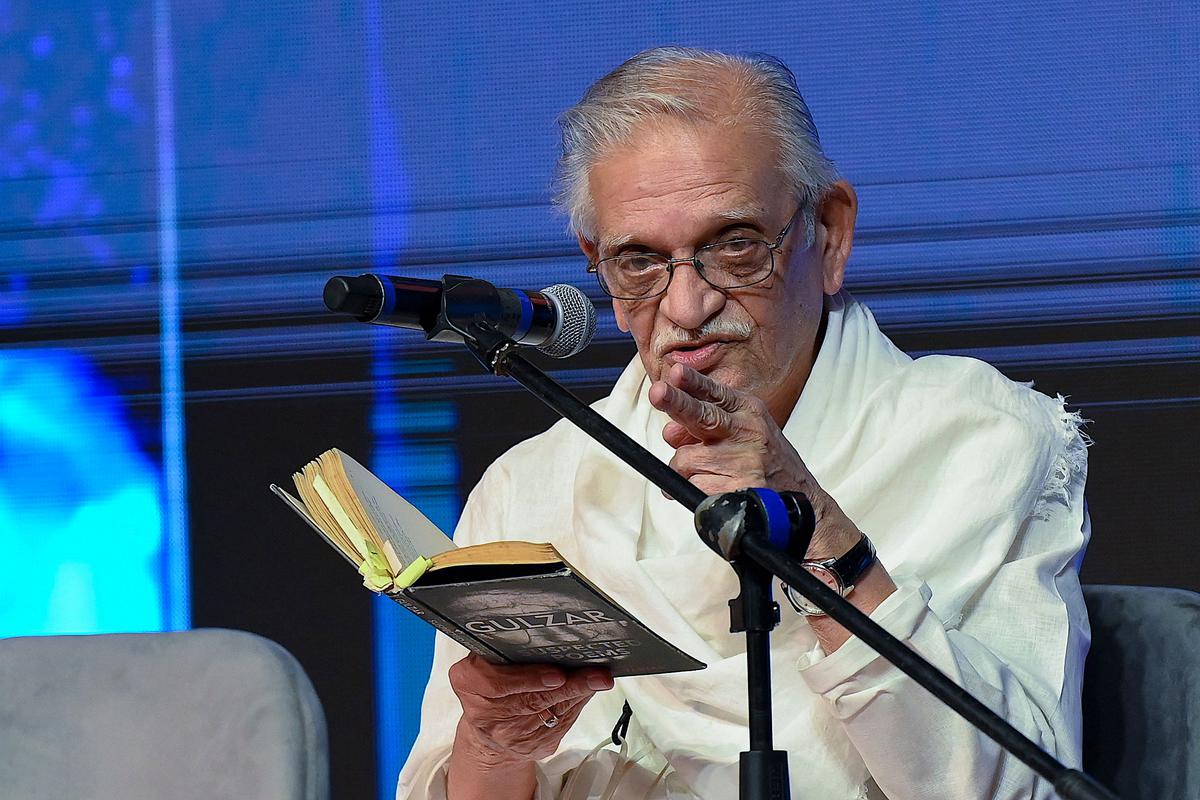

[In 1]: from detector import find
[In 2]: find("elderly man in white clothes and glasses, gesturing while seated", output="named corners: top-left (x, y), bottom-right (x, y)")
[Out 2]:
top-left (398, 48), bottom-right (1088, 800)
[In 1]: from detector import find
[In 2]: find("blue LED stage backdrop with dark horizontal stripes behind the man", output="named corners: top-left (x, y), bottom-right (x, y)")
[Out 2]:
top-left (0, 0), bottom-right (1200, 798)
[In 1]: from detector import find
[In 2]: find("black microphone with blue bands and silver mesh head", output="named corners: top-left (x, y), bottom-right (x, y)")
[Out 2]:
top-left (324, 273), bottom-right (596, 359)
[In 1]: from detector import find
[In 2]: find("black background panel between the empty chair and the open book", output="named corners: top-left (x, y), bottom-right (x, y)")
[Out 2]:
top-left (187, 360), bottom-right (376, 798)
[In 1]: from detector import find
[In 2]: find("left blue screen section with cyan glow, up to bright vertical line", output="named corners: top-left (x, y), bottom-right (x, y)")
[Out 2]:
top-left (0, 4), bottom-right (188, 636)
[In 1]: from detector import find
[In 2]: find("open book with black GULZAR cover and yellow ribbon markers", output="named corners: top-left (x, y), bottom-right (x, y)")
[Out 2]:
top-left (271, 449), bottom-right (704, 676)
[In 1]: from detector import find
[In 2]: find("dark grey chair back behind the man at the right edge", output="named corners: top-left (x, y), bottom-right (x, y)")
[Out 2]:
top-left (1084, 587), bottom-right (1200, 800)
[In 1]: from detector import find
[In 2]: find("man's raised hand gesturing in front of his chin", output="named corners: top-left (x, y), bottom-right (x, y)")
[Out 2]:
top-left (649, 363), bottom-right (859, 558)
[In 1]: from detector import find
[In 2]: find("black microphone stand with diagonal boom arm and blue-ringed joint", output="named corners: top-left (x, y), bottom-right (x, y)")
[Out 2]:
top-left (443, 316), bottom-right (1117, 800)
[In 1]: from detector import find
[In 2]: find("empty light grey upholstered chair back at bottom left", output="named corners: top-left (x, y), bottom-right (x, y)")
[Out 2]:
top-left (0, 630), bottom-right (329, 800)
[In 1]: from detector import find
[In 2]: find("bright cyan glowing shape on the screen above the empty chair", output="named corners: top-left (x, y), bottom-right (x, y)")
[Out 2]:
top-left (0, 350), bottom-right (166, 636)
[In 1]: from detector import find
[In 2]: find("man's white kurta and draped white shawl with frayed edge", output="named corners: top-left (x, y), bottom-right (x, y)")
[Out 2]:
top-left (397, 293), bottom-right (1088, 800)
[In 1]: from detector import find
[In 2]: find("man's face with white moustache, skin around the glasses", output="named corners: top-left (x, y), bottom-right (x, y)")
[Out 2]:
top-left (581, 119), bottom-right (853, 425)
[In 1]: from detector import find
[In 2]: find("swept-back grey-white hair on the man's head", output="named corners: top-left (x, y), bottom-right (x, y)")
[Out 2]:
top-left (556, 47), bottom-right (838, 241)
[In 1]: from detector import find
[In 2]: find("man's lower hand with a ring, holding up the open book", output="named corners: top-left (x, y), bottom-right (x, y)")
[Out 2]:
top-left (450, 654), bottom-right (612, 766)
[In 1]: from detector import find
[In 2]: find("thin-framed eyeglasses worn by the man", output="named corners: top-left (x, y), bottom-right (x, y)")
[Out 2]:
top-left (588, 204), bottom-right (804, 300)
